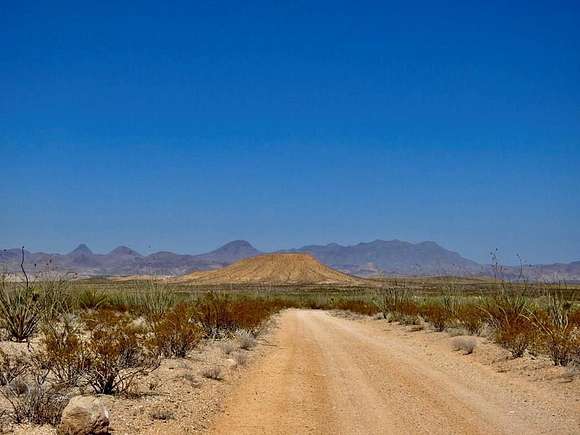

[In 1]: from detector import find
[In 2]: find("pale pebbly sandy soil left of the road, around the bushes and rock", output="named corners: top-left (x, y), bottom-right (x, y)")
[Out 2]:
top-left (0, 330), bottom-right (275, 435)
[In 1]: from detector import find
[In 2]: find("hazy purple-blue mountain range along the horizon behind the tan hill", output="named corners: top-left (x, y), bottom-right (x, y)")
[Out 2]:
top-left (0, 240), bottom-right (580, 281)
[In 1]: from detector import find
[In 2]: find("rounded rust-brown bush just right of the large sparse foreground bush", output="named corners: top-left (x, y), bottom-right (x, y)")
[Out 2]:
top-left (151, 304), bottom-right (203, 358)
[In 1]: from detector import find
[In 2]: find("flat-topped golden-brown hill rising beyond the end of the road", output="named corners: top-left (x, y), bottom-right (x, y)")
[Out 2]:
top-left (175, 254), bottom-right (365, 285)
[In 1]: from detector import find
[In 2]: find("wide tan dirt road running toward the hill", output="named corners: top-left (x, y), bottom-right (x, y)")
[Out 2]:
top-left (212, 310), bottom-right (580, 434)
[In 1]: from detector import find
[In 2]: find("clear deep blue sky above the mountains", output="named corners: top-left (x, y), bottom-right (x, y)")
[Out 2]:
top-left (0, 1), bottom-right (580, 263)
